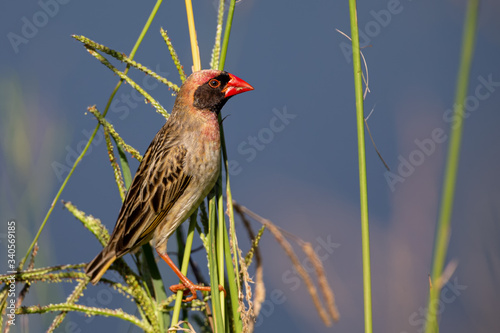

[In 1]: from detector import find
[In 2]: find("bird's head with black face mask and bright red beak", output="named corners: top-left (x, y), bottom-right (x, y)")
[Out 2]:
top-left (178, 70), bottom-right (253, 113)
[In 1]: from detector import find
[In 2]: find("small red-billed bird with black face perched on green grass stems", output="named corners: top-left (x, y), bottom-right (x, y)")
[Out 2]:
top-left (85, 70), bottom-right (254, 302)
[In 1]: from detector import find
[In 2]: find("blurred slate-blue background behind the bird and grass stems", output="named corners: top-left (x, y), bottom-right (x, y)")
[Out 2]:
top-left (0, 0), bottom-right (500, 333)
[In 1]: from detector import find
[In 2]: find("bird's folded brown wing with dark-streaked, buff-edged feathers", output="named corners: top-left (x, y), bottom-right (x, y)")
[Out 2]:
top-left (110, 128), bottom-right (191, 256)
